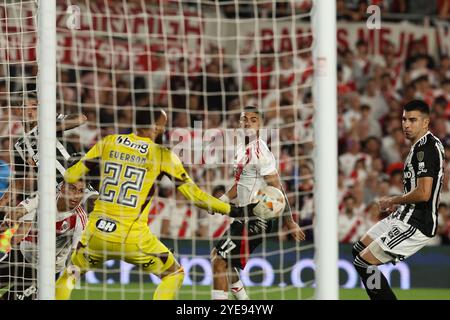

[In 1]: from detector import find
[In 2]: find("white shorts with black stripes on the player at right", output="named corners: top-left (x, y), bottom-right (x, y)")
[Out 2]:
top-left (367, 215), bottom-right (433, 263)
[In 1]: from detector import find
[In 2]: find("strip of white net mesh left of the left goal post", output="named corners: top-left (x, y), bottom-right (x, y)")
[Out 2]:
top-left (0, 1), bottom-right (38, 298)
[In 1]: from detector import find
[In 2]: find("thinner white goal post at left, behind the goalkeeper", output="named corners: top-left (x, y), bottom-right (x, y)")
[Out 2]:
top-left (37, 0), bottom-right (56, 300)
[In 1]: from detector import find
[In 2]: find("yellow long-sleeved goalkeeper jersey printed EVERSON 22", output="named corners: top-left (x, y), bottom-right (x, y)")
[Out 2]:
top-left (65, 134), bottom-right (230, 243)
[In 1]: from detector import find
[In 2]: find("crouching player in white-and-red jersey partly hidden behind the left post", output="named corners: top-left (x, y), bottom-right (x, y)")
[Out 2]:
top-left (0, 180), bottom-right (87, 300)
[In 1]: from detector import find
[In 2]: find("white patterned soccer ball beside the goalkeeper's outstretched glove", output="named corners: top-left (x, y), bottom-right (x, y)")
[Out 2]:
top-left (252, 186), bottom-right (286, 220)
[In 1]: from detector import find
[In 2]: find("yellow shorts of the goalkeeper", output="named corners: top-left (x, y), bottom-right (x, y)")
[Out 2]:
top-left (72, 232), bottom-right (175, 275)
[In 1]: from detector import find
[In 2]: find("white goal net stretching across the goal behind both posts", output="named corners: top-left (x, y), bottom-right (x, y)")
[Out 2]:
top-left (0, 0), bottom-right (314, 299)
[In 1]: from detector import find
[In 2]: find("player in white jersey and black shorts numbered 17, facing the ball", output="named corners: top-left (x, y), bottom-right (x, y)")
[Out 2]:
top-left (211, 107), bottom-right (305, 300)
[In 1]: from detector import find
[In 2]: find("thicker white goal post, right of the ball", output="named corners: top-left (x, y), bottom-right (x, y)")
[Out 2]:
top-left (312, 0), bottom-right (339, 300)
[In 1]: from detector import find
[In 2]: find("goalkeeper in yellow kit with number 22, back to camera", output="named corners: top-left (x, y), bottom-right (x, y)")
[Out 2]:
top-left (56, 109), bottom-right (250, 299)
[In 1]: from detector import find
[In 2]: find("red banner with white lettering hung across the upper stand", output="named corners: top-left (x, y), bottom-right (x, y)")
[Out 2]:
top-left (0, 2), bottom-right (450, 72)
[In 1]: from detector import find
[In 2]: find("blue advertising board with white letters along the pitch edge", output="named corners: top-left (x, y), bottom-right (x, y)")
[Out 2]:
top-left (85, 240), bottom-right (450, 289)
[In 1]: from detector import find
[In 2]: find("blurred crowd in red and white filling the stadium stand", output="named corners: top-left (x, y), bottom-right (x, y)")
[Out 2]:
top-left (0, 0), bottom-right (450, 244)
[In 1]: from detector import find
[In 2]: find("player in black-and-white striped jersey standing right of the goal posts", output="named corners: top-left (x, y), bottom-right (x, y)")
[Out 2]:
top-left (353, 100), bottom-right (444, 300)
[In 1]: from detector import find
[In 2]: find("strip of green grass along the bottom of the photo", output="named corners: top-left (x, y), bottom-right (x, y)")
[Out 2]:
top-left (72, 284), bottom-right (450, 300)
